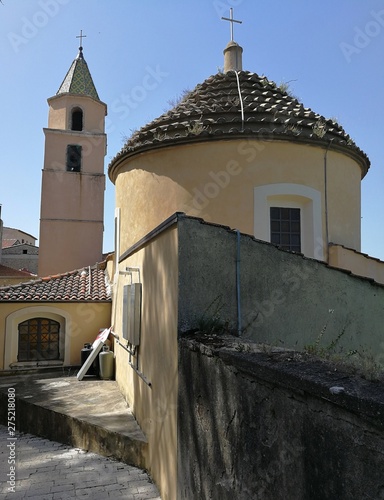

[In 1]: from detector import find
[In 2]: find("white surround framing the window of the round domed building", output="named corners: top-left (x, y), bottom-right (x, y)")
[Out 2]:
top-left (254, 183), bottom-right (325, 260)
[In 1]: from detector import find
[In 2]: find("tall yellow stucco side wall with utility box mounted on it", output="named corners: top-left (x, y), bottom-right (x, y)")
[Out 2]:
top-left (112, 224), bottom-right (178, 500)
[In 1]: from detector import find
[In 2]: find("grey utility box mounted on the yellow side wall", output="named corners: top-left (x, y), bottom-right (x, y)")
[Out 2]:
top-left (123, 283), bottom-right (141, 346)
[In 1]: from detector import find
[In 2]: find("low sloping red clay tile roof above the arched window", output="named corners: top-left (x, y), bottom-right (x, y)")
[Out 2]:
top-left (0, 266), bottom-right (111, 302)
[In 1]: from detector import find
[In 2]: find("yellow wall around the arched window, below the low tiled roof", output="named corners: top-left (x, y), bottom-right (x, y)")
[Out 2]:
top-left (0, 302), bottom-right (111, 370)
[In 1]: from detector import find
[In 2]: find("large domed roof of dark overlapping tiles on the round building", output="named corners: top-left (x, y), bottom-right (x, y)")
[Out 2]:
top-left (108, 71), bottom-right (370, 180)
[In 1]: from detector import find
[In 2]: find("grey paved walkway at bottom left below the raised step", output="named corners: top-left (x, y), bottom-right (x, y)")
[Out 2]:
top-left (0, 425), bottom-right (161, 500)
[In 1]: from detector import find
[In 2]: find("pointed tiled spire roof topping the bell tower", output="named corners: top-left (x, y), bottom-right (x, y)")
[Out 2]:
top-left (56, 47), bottom-right (100, 101)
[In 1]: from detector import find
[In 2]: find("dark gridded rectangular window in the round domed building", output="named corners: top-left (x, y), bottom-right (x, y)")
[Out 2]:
top-left (270, 207), bottom-right (301, 252)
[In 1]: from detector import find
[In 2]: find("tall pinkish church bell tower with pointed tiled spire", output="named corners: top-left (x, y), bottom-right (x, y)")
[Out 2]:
top-left (38, 33), bottom-right (107, 276)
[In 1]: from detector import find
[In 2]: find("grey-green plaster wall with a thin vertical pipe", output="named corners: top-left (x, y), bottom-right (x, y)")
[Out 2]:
top-left (178, 218), bottom-right (384, 365)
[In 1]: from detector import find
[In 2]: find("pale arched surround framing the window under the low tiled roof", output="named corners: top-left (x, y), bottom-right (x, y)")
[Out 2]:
top-left (4, 306), bottom-right (71, 370)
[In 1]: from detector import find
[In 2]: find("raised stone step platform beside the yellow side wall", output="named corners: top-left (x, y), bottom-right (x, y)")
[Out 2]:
top-left (0, 373), bottom-right (148, 468)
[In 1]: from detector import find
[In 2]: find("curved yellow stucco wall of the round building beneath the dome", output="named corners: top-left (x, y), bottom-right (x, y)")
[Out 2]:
top-left (113, 140), bottom-right (361, 259)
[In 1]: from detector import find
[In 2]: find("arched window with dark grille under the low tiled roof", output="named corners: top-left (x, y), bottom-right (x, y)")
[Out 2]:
top-left (17, 318), bottom-right (60, 361)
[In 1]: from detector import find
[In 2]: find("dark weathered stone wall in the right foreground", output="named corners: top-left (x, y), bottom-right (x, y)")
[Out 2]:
top-left (177, 336), bottom-right (384, 500)
